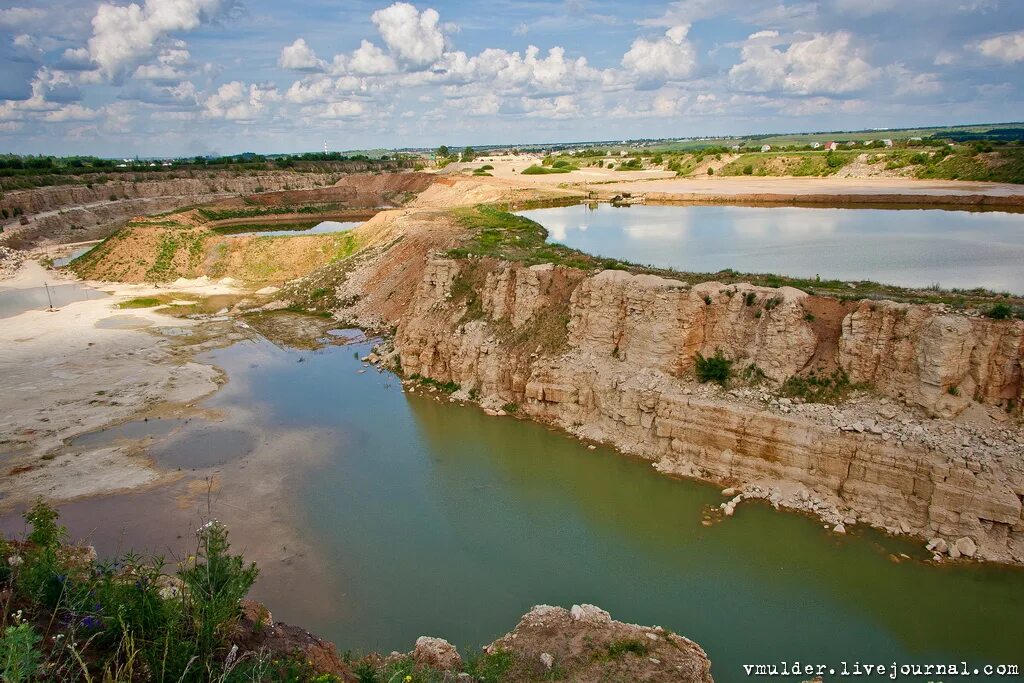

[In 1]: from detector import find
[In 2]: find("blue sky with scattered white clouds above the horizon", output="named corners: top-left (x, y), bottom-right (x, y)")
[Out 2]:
top-left (0, 0), bottom-right (1024, 157)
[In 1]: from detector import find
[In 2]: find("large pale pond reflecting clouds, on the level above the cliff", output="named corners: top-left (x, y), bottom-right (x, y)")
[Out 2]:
top-left (519, 204), bottom-right (1024, 294)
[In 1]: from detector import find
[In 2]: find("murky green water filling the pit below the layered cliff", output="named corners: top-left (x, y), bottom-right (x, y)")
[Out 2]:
top-left (197, 343), bottom-right (1024, 681)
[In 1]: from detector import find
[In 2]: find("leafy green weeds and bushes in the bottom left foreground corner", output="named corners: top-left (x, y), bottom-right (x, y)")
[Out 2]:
top-left (0, 502), bottom-right (348, 683)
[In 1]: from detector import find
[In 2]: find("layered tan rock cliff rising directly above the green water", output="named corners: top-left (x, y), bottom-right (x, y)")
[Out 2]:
top-left (377, 258), bottom-right (1024, 561)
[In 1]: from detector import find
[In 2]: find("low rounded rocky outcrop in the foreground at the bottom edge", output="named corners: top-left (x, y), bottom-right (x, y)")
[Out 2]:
top-left (486, 605), bottom-right (714, 683)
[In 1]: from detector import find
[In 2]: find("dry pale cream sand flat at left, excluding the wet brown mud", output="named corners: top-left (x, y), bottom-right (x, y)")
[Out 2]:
top-left (0, 261), bottom-right (239, 501)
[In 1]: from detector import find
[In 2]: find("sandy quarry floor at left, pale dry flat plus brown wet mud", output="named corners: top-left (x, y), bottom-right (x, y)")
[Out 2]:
top-left (0, 261), bottom-right (340, 618)
